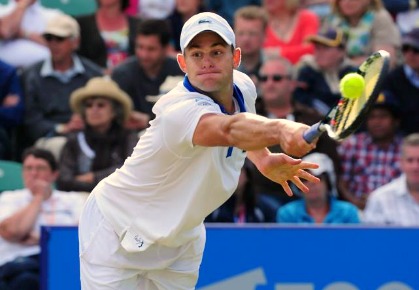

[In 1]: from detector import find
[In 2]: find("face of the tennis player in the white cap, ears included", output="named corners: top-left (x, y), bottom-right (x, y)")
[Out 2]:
top-left (178, 32), bottom-right (240, 97)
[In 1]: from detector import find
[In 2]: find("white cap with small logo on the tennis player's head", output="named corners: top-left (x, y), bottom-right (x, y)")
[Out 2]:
top-left (180, 12), bottom-right (236, 52)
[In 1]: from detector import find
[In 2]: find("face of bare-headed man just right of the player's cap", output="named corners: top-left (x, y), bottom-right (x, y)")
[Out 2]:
top-left (234, 18), bottom-right (265, 57)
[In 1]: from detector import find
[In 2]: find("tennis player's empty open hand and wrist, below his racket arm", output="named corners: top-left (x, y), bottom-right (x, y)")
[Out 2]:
top-left (247, 148), bottom-right (319, 196)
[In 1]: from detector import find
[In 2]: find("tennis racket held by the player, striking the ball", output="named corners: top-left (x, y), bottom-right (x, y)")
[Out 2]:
top-left (303, 50), bottom-right (390, 143)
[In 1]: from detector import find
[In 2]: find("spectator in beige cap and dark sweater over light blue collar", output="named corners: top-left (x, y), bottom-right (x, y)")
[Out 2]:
top-left (23, 15), bottom-right (102, 144)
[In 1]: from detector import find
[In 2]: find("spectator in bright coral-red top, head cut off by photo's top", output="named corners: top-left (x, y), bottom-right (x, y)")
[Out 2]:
top-left (263, 0), bottom-right (320, 64)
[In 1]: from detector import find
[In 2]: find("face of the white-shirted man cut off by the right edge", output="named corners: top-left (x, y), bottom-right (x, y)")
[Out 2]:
top-left (400, 146), bottom-right (419, 190)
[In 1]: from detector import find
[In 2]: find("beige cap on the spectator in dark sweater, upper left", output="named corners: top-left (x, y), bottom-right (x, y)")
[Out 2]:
top-left (43, 14), bottom-right (80, 37)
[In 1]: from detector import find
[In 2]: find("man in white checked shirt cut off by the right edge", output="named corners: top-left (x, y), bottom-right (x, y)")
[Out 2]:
top-left (364, 133), bottom-right (419, 226)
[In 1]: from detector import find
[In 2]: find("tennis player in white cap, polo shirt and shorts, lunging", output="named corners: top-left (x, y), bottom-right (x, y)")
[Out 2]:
top-left (79, 13), bottom-right (318, 290)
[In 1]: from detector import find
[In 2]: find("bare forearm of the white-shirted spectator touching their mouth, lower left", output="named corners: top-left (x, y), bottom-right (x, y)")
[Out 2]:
top-left (0, 196), bottom-right (43, 242)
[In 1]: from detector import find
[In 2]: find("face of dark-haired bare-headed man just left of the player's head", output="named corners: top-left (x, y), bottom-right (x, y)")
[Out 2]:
top-left (135, 35), bottom-right (167, 73)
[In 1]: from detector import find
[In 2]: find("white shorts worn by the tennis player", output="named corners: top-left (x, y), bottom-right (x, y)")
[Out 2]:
top-left (79, 195), bottom-right (205, 290)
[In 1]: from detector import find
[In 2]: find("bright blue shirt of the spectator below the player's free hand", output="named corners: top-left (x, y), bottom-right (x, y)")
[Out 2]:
top-left (276, 198), bottom-right (360, 224)
